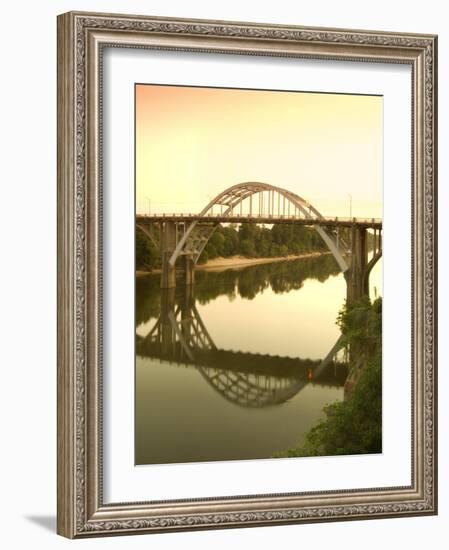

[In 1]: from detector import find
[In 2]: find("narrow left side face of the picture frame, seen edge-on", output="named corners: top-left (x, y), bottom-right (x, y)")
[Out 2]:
top-left (56, 10), bottom-right (76, 538)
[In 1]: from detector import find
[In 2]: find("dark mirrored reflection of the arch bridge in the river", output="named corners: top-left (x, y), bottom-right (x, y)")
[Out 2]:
top-left (136, 286), bottom-right (347, 408)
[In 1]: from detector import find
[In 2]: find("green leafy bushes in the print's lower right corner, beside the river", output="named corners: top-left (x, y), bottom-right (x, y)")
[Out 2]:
top-left (274, 298), bottom-right (382, 457)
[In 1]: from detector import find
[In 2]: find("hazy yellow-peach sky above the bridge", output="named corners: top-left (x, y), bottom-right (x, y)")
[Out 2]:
top-left (136, 85), bottom-right (383, 217)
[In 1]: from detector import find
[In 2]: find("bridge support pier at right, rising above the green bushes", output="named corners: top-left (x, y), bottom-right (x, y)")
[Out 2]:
top-left (345, 226), bottom-right (369, 304)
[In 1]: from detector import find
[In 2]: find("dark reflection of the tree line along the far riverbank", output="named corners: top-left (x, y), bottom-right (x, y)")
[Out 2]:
top-left (136, 255), bottom-right (340, 325)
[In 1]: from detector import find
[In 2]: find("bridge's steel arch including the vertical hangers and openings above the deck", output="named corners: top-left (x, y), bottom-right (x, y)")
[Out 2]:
top-left (169, 182), bottom-right (349, 272)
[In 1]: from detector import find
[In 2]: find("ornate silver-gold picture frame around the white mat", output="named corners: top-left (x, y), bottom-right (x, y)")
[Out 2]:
top-left (57, 12), bottom-right (437, 538)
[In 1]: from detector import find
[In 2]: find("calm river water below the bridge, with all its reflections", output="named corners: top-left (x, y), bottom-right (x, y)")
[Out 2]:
top-left (136, 255), bottom-right (382, 464)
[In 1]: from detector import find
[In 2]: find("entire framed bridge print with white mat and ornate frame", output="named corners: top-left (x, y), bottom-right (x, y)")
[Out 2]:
top-left (58, 12), bottom-right (437, 538)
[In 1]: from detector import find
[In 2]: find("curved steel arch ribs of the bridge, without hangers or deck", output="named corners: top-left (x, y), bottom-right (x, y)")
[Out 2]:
top-left (169, 182), bottom-right (349, 272)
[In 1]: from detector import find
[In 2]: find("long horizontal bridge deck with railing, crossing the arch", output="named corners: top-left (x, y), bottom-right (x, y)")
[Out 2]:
top-left (136, 213), bottom-right (382, 229)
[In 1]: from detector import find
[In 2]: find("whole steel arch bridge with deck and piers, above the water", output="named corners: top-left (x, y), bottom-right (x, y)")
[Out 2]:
top-left (136, 182), bottom-right (382, 301)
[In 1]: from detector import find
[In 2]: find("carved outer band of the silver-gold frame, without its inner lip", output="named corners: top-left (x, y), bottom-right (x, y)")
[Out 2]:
top-left (57, 12), bottom-right (437, 538)
